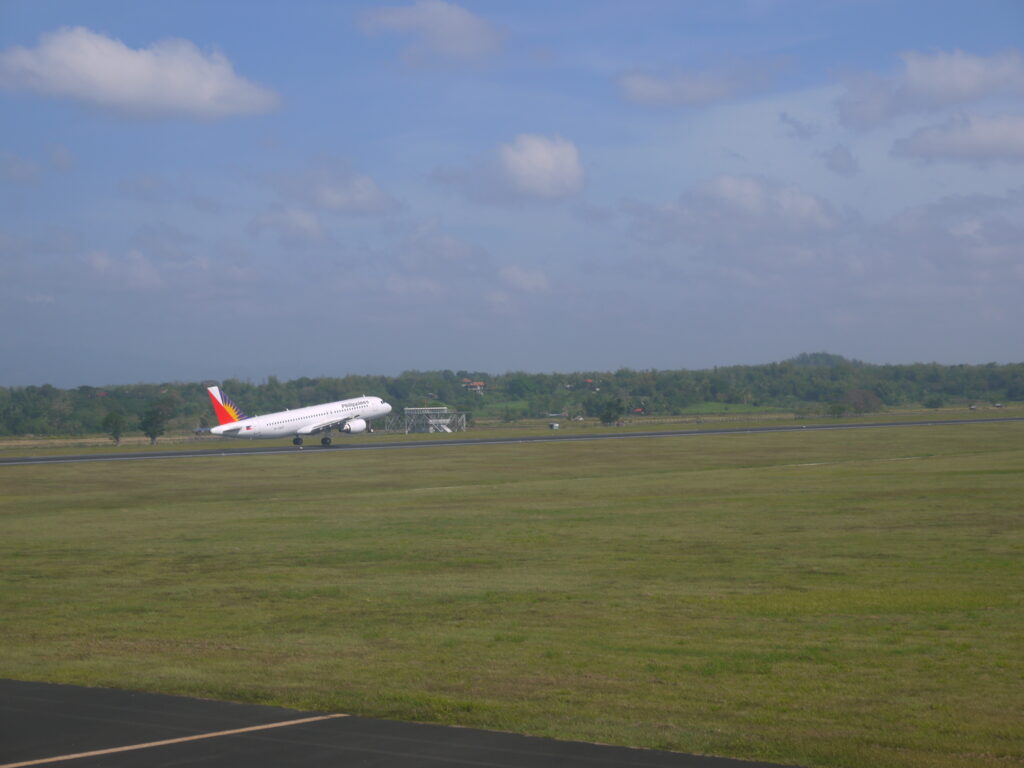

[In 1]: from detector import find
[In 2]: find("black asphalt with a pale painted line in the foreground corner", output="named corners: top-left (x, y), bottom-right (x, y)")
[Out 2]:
top-left (0, 680), bottom-right (779, 768)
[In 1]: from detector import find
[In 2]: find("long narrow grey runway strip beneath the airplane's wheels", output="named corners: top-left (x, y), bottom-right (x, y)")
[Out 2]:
top-left (0, 417), bottom-right (1024, 467)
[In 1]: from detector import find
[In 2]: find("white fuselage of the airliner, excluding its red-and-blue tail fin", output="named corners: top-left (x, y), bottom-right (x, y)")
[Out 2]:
top-left (210, 397), bottom-right (391, 440)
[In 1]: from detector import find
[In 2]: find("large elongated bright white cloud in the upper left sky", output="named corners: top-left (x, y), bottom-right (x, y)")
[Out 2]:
top-left (0, 27), bottom-right (279, 119)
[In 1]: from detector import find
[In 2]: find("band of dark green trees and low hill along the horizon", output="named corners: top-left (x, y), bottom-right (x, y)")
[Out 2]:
top-left (0, 352), bottom-right (1024, 436)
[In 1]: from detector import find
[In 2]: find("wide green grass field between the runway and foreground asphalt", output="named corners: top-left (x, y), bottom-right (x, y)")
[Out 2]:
top-left (0, 423), bottom-right (1024, 767)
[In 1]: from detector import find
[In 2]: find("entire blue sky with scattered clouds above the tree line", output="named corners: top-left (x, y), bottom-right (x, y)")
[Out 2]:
top-left (0, 0), bottom-right (1024, 387)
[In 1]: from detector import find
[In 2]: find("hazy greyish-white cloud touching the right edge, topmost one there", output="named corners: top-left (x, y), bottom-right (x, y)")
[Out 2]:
top-left (838, 50), bottom-right (1024, 128)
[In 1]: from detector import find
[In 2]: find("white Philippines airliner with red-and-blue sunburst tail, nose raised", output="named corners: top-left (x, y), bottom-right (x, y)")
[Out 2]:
top-left (207, 387), bottom-right (391, 447)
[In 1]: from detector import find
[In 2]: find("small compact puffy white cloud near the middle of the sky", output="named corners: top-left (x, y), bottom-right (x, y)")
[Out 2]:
top-left (499, 133), bottom-right (584, 199)
